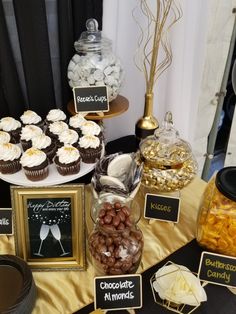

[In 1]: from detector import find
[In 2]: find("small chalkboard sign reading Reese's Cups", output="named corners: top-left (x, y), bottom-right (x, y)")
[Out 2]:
top-left (73, 86), bottom-right (109, 112)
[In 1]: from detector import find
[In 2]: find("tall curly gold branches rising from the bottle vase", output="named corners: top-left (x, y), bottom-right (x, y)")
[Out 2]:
top-left (133, 0), bottom-right (182, 94)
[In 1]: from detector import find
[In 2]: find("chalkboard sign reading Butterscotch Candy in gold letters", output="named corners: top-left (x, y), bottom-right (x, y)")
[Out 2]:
top-left (198, 252), bottom-right (236, 287)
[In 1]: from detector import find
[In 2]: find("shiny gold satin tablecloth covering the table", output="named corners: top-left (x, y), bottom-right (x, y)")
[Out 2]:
top-left (0, 178), bottom-right (206, 314)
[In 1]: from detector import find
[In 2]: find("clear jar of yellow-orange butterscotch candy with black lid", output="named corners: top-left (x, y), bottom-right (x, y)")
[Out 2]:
top-left (197, 167), bottom-right (236, 257)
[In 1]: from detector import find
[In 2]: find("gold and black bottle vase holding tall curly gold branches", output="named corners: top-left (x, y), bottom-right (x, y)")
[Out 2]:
top-left (133, 0), bottom-right (182, 140)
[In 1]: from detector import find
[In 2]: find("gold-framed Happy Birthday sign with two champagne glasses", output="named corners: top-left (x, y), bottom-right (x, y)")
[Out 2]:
top-left (11, 184), bottom-right (85, 270)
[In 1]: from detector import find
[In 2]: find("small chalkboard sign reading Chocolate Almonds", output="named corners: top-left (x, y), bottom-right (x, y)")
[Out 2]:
top-left (94, 274), bottom-right (142, 310)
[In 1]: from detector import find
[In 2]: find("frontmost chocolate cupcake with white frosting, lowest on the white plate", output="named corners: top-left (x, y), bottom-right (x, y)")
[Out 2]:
top-left (20, 147), bottom-right (49, 181)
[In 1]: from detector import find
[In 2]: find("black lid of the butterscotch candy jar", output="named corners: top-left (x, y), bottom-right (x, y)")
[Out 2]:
top-left (215, 167), bottom-right (236, 201)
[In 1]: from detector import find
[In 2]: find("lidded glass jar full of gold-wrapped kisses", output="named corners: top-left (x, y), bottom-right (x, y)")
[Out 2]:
top-left (139, 112), bottom-right (197, 192)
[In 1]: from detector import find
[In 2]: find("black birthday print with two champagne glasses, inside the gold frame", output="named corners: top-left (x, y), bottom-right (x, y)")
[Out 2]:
top-left (26, 197), bottom-right (73, 258)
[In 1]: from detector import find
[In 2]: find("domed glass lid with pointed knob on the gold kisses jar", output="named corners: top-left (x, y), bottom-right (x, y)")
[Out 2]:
top-left (139, 111), bottom-right (192, 166)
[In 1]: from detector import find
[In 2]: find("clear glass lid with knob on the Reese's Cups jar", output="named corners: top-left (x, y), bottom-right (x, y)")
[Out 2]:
top-left (74, 19), bottom-right (111, 53)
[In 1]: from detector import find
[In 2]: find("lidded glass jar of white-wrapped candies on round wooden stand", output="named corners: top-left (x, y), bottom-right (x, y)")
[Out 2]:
top-left (67, 19), bottom-right (123, 102)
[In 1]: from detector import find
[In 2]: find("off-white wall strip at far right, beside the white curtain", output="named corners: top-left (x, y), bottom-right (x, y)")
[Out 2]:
top-left (193, 0), bottom-right (236, 177)
